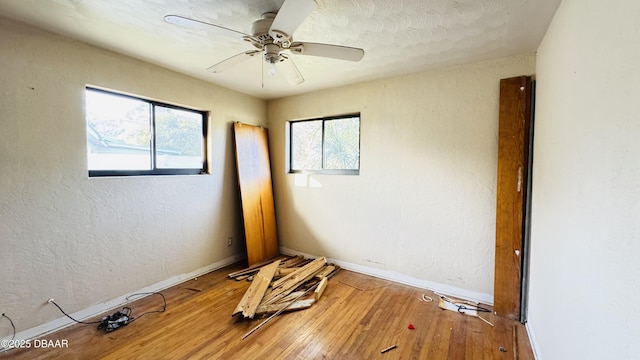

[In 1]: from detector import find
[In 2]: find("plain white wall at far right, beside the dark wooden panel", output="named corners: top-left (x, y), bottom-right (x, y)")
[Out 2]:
top-left (529, 0), bottom-right (640, 360)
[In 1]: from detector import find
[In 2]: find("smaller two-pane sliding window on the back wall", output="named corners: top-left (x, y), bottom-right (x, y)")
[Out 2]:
top-left (287, 114), bottom-right (360, 175)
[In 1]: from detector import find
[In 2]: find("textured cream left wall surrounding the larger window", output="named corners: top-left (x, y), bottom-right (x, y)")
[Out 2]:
top-left (0, 18), bottom-right (266, 336)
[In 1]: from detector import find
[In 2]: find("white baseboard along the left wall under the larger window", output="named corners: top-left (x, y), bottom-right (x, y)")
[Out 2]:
top-left (0, 255), bottom-right (246, 352)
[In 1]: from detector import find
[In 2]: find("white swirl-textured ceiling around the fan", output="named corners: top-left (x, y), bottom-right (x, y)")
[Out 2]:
top-left (0, 0), bottom-right (561, 99)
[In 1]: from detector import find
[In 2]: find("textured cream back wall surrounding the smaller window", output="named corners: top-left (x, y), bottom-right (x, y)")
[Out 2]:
top-left (268, 56), bottom-right (535, 299)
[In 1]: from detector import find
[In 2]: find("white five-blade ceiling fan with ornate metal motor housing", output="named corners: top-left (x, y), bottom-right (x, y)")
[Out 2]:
top-left (164, 0), bottom-right (364, 85)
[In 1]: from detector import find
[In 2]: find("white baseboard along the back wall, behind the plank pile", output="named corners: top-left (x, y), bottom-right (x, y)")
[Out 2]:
top-left (280, 246), bottom-right (493, 305)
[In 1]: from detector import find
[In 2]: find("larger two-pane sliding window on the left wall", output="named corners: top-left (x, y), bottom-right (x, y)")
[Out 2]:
top-left (85, 87), bottom-right (207, 177)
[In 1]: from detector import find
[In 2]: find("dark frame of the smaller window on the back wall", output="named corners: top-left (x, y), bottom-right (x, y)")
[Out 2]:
top-left (285, 112), bottom-right (362, 175)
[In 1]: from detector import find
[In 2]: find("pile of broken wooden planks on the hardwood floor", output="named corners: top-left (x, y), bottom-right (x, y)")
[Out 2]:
top-left (229, 256), bottom-right (339, 319)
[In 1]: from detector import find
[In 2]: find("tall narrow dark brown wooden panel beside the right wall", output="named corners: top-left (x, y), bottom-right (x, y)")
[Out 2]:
top-left (494, 76), bottom-right (531, 319)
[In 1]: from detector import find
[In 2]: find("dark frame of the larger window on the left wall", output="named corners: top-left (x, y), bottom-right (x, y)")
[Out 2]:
top-left (85, 85), bottom-right (210, 178)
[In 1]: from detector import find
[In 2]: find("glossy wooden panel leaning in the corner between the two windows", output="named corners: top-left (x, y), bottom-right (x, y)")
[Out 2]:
top-left (233, 123), bottom-right (280, 265)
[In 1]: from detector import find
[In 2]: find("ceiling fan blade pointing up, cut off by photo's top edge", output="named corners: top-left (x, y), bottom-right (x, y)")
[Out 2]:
top-left (269, 0), bottom-right (316, 43)
